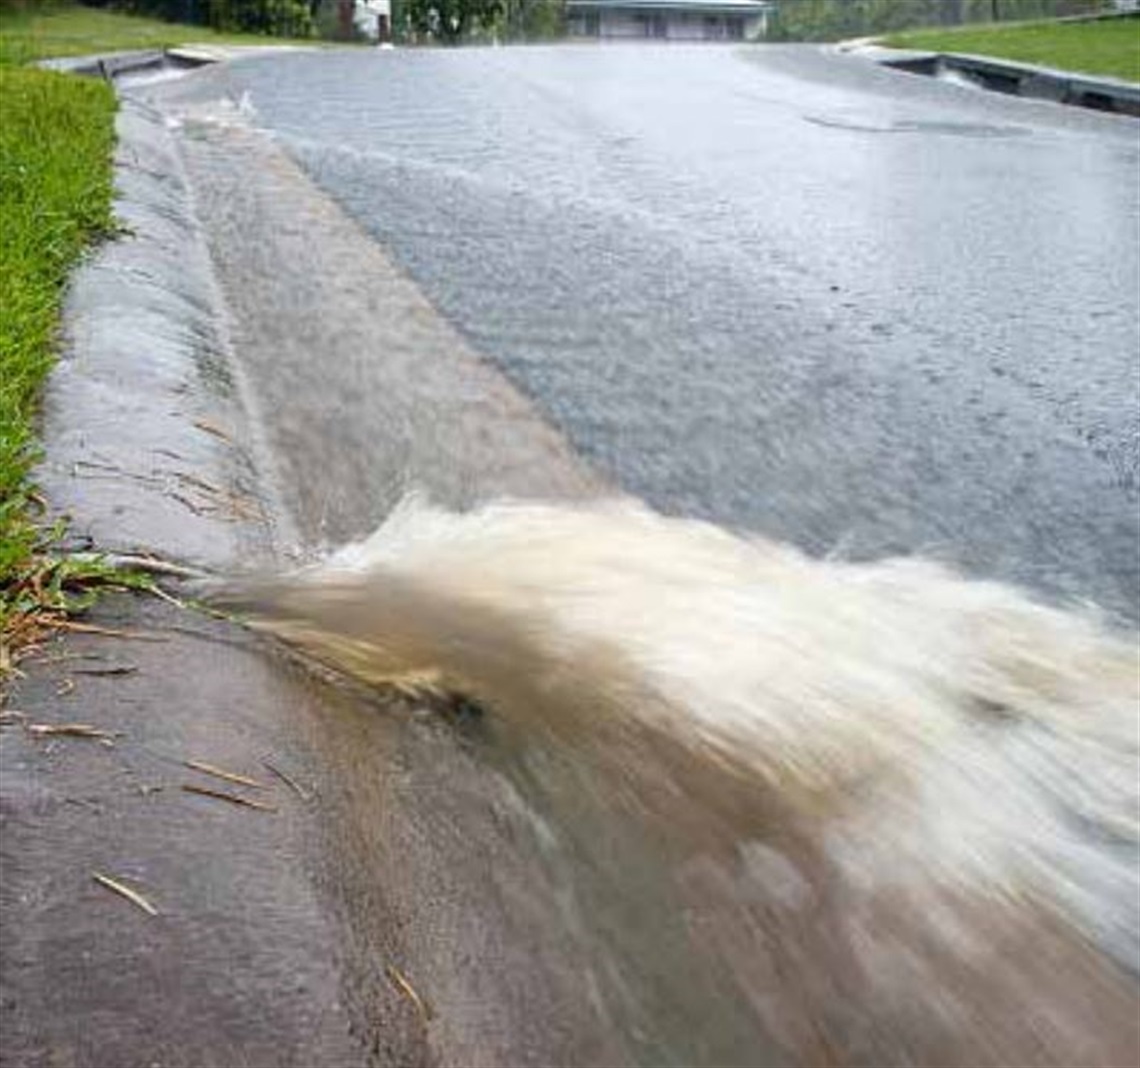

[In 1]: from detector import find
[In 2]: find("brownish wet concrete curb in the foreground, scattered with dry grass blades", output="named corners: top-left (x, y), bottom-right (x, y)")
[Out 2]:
top-left (0, 601), bottom-right (373, 1068)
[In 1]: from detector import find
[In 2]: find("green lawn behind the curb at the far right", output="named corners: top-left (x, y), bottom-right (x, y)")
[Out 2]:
top-left (882, 18), bottom-right (1140, 82)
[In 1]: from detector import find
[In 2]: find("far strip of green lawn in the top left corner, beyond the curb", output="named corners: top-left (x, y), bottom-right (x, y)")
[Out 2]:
top-left (0, 5), bottom-right (317, 64)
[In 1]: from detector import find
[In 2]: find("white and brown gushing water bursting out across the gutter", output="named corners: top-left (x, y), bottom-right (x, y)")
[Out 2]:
top-left (220, 498), bottom-right (1140, 1065)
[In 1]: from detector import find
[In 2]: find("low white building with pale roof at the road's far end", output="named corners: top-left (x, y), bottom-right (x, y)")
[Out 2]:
top-left (567, 0), bottom-right (775, 41)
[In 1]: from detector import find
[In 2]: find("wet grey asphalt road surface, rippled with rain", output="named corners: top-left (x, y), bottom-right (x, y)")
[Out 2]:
top-left (207, 47), bottom-right (1140, 618)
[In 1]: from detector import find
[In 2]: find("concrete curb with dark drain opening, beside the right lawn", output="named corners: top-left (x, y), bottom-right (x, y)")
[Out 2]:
top-left (836, 38), bottom-right (1140, 117)
